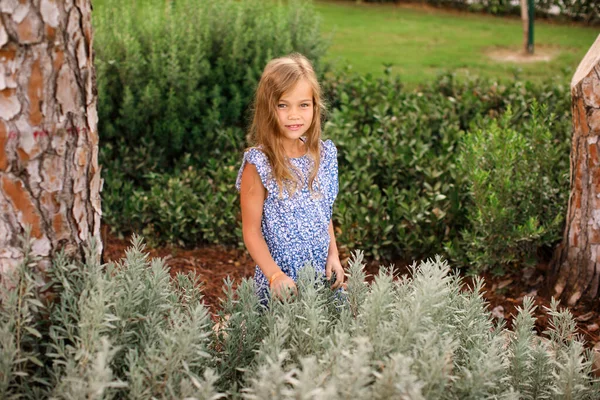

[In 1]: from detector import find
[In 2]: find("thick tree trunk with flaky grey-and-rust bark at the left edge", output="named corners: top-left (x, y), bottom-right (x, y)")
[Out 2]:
top-left (0, 0), bottom-right (102, 288)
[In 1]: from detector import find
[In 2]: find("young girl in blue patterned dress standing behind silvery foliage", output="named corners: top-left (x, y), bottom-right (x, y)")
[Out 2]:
top-left (236, 54), bottom-right (344, 303)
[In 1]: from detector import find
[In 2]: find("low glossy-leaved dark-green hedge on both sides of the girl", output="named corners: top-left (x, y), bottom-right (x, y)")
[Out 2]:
top-left (101, 74), bottom-right (571, 272)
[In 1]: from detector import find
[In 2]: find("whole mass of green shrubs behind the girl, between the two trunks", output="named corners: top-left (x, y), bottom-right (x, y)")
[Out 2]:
top-left (96, 0), bottom-right (570, 272)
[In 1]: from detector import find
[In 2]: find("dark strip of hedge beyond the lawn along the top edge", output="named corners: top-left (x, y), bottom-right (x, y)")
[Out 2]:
top-left (359, 0), bottom-right (600, 25)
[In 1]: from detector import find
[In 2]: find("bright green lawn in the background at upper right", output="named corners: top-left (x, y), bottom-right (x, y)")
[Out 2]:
top-left (315, 0), bottom-right (600, 86)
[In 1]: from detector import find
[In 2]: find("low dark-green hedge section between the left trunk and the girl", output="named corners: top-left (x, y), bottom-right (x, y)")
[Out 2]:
top-left (102, 152), bottom-right (243, 247)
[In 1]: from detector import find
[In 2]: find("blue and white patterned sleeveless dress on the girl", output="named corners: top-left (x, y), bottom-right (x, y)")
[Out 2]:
top-left (235, 140), bottom-right (338, 304)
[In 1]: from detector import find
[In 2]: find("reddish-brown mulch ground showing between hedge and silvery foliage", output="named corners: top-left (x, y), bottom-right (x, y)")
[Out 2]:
top-left (103, 234), bottom-right (600, 348)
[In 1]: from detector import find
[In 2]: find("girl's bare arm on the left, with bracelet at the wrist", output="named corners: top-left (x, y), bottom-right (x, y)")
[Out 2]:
top-left (240, 163), bottom-right (295, 291)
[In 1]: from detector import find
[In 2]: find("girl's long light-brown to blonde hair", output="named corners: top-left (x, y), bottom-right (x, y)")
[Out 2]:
top-left (248, 53), bottom-right (325, 196)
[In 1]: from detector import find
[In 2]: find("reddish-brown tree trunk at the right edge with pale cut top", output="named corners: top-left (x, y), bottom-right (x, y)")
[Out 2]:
top-left (552, 36), bottom-right (600, 305)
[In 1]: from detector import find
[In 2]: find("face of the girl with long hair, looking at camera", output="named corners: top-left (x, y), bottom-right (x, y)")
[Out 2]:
top-left (277, 79), bottom-right (314, 140)
